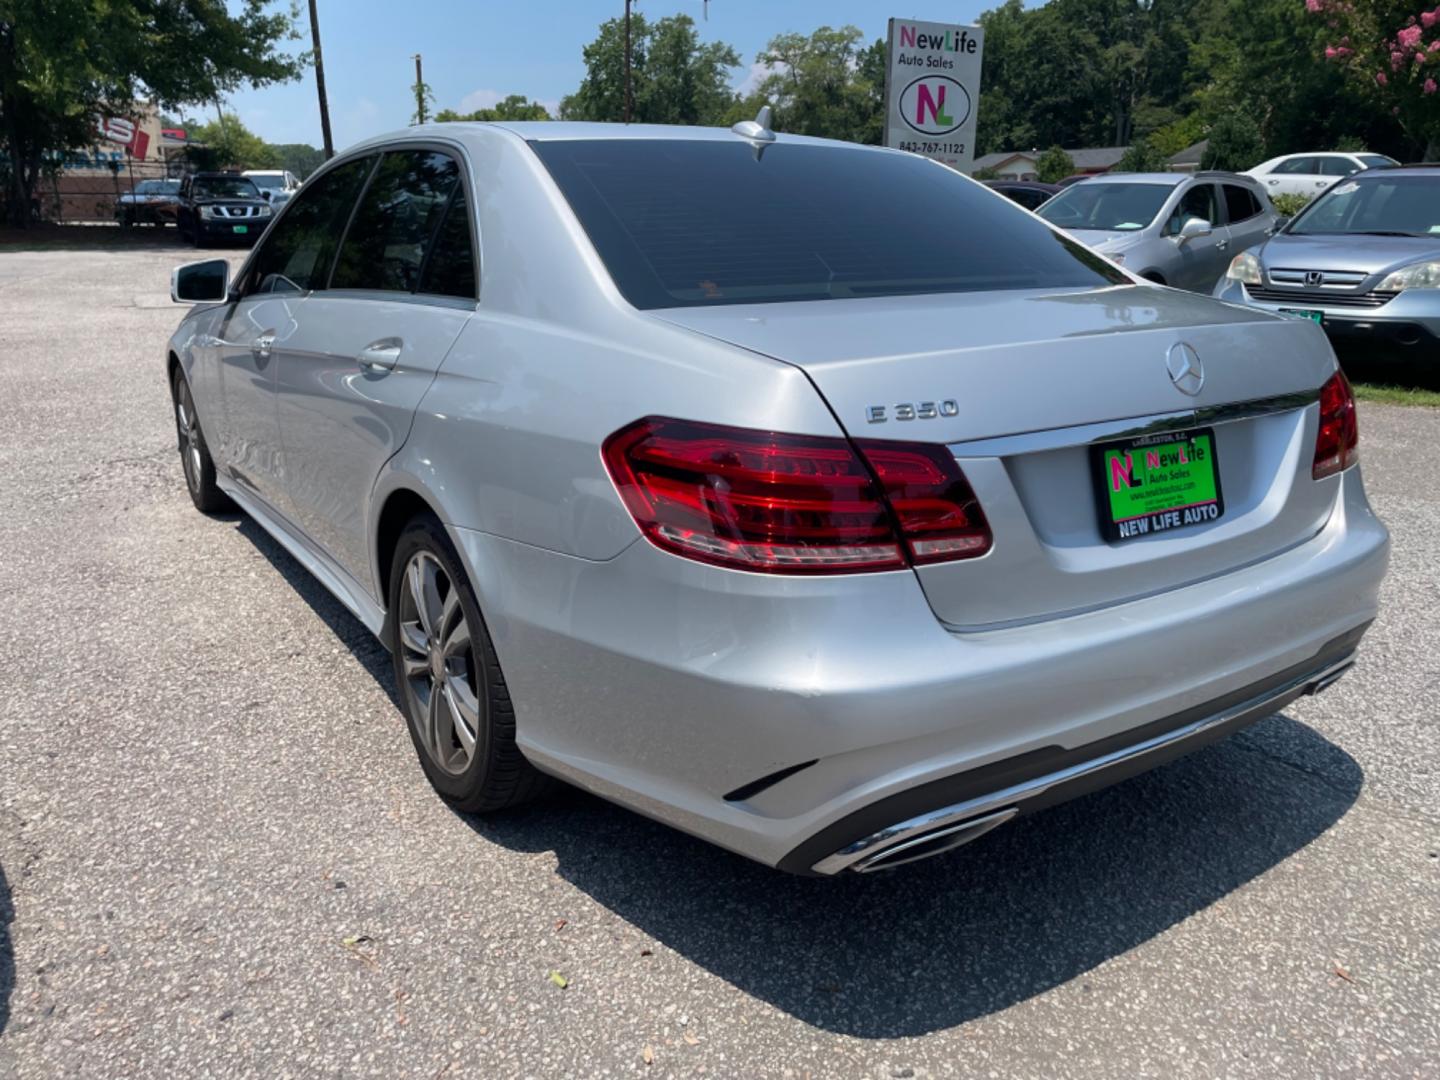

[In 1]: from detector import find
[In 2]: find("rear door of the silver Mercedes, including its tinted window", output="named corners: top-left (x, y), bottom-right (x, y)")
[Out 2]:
top-left (276, 147), bottom-right (477, 593)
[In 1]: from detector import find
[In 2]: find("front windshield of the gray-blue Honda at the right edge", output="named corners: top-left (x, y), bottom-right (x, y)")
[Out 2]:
top-left (1286, 170), bottom-right (1440, 236)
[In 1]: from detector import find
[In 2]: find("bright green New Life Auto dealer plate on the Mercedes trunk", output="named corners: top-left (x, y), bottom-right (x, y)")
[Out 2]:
top-left (1092, 428), bottom-right (1225, 543)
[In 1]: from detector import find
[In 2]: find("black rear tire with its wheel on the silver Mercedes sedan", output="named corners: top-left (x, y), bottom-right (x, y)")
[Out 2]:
top-left (386, 514), bottom-right (554, 814)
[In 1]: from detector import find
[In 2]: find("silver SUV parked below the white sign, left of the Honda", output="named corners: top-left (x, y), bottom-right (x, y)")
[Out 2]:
top-left (1037, 171), bottom-right (1282, 292)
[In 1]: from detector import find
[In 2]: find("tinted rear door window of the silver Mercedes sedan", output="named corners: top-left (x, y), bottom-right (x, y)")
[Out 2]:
top-left (330, 150), bottom-right (459, 292)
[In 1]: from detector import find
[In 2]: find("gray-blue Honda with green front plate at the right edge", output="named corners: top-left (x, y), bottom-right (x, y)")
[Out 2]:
top-left (1215, 166), bottom-right (1440, 363)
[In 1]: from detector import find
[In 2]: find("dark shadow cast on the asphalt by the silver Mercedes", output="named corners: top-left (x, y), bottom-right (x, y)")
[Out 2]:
top-left (216, 514), bottom-right (1364, 1038)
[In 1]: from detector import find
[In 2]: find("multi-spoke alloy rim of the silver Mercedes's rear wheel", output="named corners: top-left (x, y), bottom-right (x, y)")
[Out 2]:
top-left (399, 552), bottom-right (481, 776)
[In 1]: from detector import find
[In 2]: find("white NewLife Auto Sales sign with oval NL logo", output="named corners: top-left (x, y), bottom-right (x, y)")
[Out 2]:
top-left (886, 19), bottom-right (985, 173)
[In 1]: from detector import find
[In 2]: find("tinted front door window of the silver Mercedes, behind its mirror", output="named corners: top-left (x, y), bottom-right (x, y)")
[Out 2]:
top-left (246, 157), bottom-right (374, 292)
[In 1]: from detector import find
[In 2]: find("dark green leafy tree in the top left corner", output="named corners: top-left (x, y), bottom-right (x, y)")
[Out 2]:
top-left (0, 0), bottom-right (307, 226)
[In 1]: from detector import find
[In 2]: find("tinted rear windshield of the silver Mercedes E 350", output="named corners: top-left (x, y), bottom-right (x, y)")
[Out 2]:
top-left (531, 138), bottom-right (1128, 308)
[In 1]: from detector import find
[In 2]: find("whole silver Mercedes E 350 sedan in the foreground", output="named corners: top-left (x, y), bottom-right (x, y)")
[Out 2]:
top-left (167, 120), bottom-right (1388, 874)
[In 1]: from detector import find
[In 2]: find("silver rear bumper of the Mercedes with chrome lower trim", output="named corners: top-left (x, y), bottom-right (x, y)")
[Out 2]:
top-left (451, 469), bottom-right (1388, 873)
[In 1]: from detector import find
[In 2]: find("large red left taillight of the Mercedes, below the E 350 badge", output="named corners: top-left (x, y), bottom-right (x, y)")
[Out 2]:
top-left (603, 418), bottom-right (989, 573)
